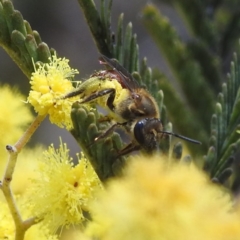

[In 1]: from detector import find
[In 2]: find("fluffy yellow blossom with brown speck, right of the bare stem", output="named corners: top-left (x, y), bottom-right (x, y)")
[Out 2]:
top-left (26, 141), bottom-right (101, 232)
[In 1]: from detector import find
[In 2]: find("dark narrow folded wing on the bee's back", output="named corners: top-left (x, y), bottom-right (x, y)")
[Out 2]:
top-left (100, 55), bottom-right (140, 92)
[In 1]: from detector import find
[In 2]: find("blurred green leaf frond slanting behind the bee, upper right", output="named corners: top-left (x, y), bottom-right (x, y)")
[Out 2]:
top-left (143, 5), bottom-right (214, 129)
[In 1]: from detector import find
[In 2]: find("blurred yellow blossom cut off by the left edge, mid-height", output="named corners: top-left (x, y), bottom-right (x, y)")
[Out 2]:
top-left (0, 85), bottom-right (33, 177)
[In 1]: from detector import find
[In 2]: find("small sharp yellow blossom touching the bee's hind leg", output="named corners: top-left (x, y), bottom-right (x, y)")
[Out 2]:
top-left (28, 55), bottom-right (78, 129)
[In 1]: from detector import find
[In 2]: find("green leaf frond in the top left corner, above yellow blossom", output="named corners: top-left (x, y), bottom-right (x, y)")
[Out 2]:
top-left (0, 0), bottom-right (53, 78)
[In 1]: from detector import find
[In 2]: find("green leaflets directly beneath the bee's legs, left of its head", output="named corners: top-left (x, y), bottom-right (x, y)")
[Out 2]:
top-left (72, 102), bottom-right (125, 181)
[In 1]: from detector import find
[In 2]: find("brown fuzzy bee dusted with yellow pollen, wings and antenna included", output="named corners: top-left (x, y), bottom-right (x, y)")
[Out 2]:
top-left (64, 55), bottom-right (201, 157)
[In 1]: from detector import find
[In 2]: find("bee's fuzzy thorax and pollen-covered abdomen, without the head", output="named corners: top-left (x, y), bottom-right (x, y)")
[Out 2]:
top-left (68, 67), bottom-right (159, 123)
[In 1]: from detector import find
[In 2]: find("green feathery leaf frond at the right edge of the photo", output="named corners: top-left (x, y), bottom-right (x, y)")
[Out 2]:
top-left (204, 54), bottom-right (240, 188)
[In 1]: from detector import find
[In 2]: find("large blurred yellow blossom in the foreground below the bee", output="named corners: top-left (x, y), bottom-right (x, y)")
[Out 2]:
top-left (87, 158), bottom-right (240, 240)
